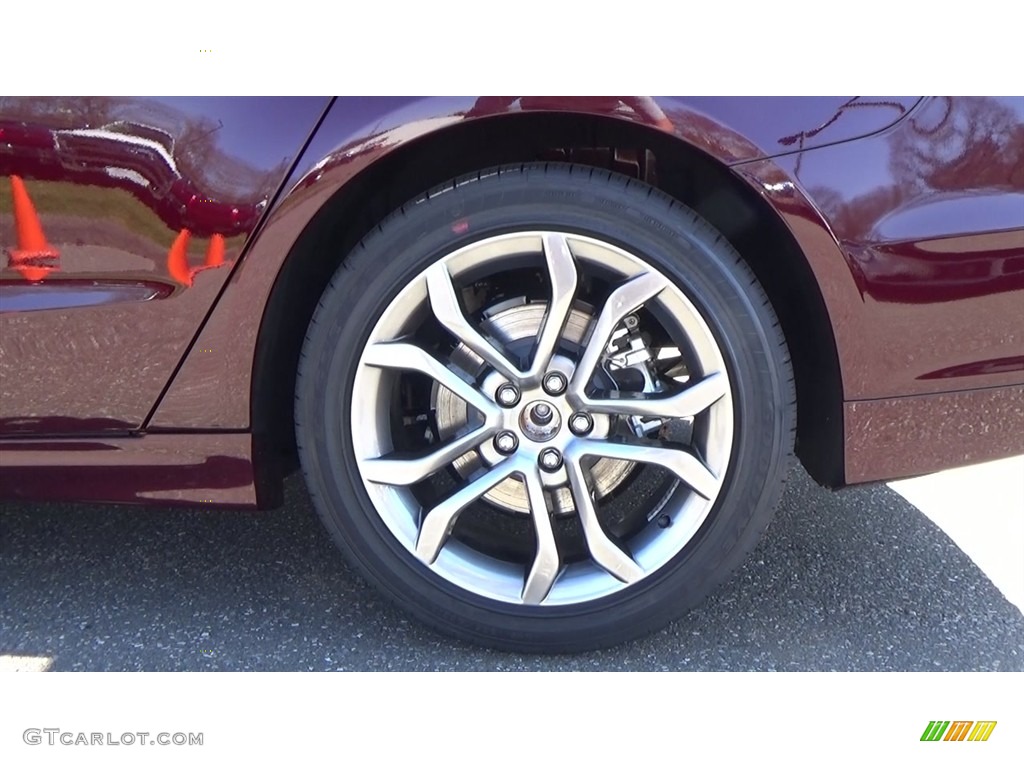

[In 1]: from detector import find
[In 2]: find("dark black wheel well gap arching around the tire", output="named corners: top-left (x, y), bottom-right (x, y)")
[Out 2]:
top-left (252, 113), bottom-right (844, 486)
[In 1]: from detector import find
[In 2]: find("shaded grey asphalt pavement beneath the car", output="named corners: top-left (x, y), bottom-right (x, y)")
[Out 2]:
top-left (0, 468), bottom-right (1024, 671)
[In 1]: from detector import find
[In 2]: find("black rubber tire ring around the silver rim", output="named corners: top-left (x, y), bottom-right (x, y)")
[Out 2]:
top-left (295, 164), bottom-right (796, 652)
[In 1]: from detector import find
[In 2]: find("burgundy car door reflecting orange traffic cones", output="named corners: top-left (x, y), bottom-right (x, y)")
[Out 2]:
top-left (0, 97), bottom-right (330, 436)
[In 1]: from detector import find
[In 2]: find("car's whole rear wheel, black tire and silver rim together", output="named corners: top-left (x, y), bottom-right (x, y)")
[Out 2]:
top-left (296, 166), bottom-right (795, 650)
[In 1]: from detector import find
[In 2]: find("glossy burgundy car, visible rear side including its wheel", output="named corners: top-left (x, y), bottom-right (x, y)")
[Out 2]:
top-left (0, 96), bottom-right (1024, 651)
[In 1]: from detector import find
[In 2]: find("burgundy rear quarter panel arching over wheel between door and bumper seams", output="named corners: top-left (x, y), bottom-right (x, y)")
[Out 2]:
top-left (148, 96), bottom-right (918, 429)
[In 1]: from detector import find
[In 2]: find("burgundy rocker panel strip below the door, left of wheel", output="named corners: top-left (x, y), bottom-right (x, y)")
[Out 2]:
top-left (0, 433), bottom-right (257, 507)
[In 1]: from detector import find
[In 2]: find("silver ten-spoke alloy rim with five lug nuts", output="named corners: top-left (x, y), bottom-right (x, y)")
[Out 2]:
top-left (349, 231), bottom-right (733, 606)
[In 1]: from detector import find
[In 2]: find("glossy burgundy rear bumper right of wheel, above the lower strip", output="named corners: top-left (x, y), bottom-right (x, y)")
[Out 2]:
top-left (736, 97), bottom-right (1024, 400)
